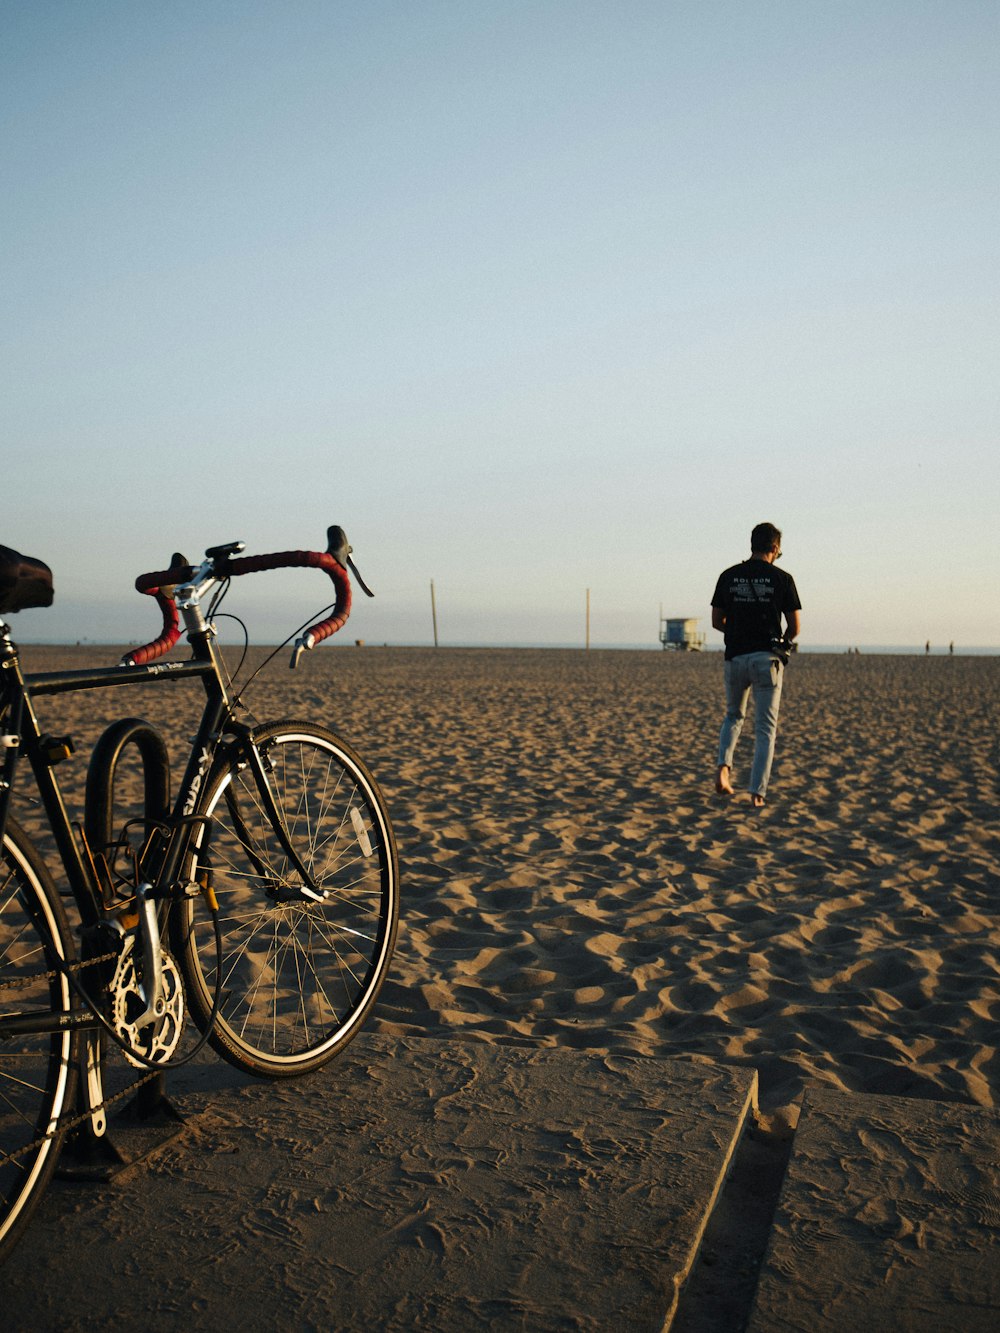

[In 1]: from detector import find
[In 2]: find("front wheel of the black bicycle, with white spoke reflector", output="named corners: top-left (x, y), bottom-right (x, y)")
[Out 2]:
top-left (172, 721), bottom-right (399, 1078)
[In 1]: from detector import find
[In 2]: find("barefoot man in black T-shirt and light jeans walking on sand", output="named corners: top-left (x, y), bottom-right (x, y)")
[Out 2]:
top-left (712, 523), bottom-right (801, 808)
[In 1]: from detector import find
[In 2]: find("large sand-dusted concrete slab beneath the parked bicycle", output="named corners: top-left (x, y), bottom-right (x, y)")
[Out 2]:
top-left (0, 1033), bottom-right (756, 1333)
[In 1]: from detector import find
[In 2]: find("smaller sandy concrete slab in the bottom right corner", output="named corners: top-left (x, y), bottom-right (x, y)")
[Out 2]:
top-left (749, 1090), bottom-right (1000, 1333)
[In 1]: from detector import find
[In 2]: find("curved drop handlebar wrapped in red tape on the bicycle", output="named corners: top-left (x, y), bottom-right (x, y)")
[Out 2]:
top-left (121, 528), bottom-right (373, 667)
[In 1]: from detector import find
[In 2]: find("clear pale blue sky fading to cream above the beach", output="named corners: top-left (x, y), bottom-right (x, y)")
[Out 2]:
top-left (0, 0), bottom-right (1000, 647)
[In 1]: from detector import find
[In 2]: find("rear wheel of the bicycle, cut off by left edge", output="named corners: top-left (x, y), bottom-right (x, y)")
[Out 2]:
top-left (0, 818), bottom-right (77, 1261)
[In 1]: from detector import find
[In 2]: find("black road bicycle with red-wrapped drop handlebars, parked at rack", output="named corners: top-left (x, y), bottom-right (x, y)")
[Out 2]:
top-left (0, 528), bottom-right (399, 1260)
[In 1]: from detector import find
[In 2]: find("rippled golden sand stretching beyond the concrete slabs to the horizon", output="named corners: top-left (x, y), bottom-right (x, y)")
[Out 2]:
top-left (15, 645), bottom-right (1000, 1133)
